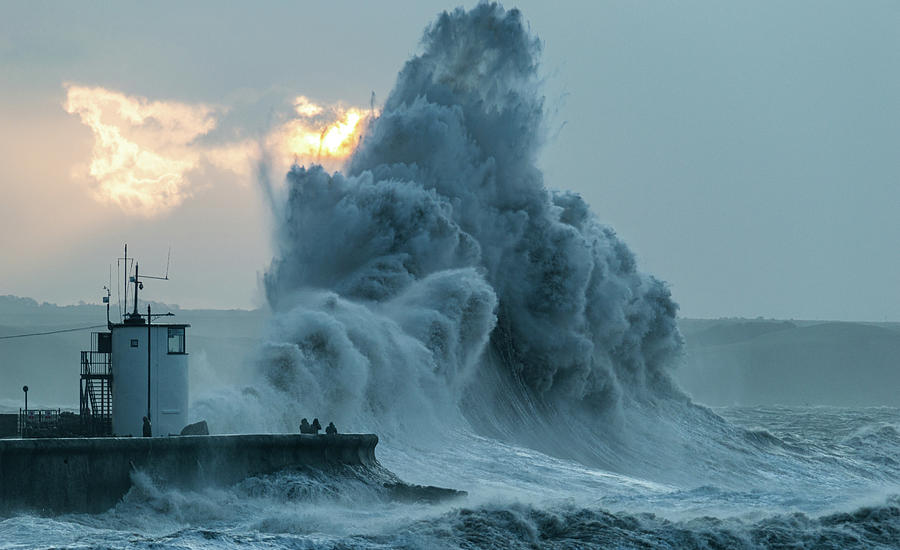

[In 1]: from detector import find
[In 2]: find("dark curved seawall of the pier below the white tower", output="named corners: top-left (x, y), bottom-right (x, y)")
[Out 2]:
top-left (0, 434), bottom-right (378, 513)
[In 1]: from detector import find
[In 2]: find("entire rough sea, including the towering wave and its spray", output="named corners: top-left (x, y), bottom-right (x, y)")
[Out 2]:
top-left (0, 3), bottom-right (900, 549)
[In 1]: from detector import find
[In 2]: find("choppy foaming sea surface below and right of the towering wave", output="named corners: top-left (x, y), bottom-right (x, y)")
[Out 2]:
top-left (0, 407), bottom-right (900, 549)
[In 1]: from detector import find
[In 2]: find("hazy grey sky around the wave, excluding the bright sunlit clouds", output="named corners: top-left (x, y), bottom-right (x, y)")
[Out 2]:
top-left (0, 1), bottom-right (900, 320)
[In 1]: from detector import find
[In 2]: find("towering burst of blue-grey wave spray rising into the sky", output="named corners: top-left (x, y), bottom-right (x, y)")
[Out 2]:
top-left (250, 4), bottom-right (681, 448)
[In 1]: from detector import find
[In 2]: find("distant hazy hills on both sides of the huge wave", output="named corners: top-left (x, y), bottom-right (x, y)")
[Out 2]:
top-left (0, 296), bottom-right (900, 412)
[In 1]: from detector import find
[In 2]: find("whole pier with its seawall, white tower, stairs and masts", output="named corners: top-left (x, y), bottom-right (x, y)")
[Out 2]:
top-left (0, 247), bottom-right (388, 517)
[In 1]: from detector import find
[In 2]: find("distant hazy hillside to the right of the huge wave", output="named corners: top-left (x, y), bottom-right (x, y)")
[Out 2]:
top-left (676, 319), bottom-right (900, 406)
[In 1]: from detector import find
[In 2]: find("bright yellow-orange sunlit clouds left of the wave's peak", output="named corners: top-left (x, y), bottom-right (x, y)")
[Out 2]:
top-left (63, 84), bottom-right (373, 217)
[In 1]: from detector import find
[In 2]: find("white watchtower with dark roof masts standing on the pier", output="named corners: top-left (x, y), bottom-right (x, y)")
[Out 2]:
top-left (109, 252), bottom-right (190, 437)
